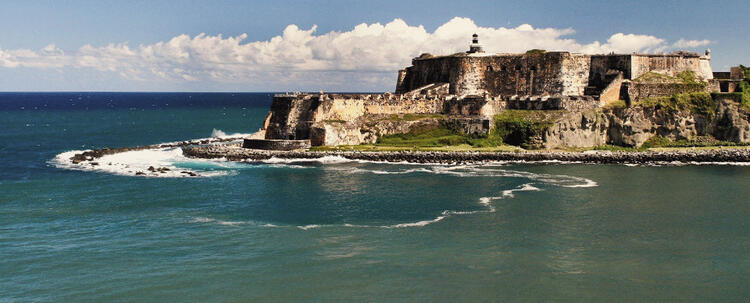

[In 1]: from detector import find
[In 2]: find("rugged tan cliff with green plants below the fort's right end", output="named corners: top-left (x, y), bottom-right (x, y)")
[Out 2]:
top-left (536, 99), bottom-right (750, 149)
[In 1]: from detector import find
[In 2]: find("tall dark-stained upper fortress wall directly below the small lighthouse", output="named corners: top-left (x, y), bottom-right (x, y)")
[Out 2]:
top-left (396, 52), bottom-right (590, 97)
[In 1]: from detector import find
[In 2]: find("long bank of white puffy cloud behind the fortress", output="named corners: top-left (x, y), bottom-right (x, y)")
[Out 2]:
top-left (0, 17), bottom-right (710, 88)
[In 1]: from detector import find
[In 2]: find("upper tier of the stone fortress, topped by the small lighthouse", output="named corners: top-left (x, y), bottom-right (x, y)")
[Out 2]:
top-left (396, 34), bottom-right (714, 104)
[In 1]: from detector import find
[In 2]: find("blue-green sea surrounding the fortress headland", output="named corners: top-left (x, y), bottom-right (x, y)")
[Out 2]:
top-left (0, 94), bottom-right (750, 302)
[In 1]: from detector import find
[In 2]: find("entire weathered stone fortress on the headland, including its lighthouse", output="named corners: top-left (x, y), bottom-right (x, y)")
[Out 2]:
top-left (251, 34), bottom-right (750, 149)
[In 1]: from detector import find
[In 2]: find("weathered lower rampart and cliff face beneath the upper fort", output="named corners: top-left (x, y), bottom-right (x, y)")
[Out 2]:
top-left (266, 93), bottom-right (750, 149)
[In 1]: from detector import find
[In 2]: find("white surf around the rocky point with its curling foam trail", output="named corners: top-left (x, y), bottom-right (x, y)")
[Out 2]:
top-left (50, 129), bottom-right (598, 230)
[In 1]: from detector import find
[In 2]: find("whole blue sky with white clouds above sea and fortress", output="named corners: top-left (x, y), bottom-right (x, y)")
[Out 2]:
top-left (0, 0), bottom-right (750, 92)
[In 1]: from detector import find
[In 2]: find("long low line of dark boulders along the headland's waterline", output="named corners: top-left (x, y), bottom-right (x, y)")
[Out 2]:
top-left (183, 145), bottom-right (750, 164)
